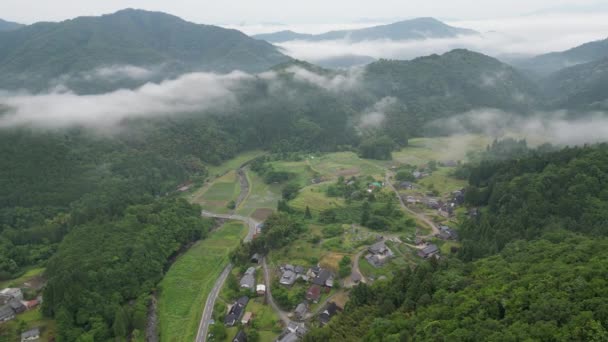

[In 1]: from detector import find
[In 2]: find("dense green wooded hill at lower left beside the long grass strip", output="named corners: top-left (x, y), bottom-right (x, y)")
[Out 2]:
top-left (42, 199), bottom-right (211, 341)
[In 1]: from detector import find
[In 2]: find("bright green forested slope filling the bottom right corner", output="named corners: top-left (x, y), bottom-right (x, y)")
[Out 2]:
top-left (305, 231), bottom-right (608, 341)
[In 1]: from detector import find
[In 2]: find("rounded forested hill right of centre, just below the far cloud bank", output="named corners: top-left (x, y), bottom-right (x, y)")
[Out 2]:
top-left (363, 50), bottom-right (541, 132)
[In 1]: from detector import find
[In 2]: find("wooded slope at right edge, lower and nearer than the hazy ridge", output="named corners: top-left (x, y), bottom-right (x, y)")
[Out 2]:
top-left (542, 58), bottom-right (608, 110)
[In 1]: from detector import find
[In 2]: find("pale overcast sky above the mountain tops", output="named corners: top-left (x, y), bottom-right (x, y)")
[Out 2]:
top-left (0, 0), bottom-right (608, 26)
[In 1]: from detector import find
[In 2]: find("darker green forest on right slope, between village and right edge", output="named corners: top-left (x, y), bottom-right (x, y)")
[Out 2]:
top-left (460, 144), bottom-right (608, 260)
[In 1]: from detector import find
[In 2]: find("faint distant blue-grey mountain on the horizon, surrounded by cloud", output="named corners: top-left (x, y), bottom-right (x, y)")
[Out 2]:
top-left (253, 18), bottom-right (477, 43)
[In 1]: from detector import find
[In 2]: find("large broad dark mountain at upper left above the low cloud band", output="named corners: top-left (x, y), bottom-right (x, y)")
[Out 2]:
top-left (0, 9), bottom-right (289, 90)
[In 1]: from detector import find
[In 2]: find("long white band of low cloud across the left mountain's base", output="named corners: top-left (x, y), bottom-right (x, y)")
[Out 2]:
top-left (0, 72), bottom-right (252, 129)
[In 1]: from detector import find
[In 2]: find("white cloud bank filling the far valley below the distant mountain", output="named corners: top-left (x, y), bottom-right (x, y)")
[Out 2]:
top-left (276, 13), bottom-right (608, 63)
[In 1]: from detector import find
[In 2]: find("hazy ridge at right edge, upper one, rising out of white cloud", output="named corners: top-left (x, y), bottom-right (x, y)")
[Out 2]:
top-left (513, 39), bottom-right (608, 77)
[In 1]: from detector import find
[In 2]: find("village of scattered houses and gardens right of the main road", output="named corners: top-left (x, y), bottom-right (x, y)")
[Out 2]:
top-left (208, 154), bottom-right (466, 342)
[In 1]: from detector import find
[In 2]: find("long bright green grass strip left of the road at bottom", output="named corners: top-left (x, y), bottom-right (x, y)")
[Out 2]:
top-left (158, 222), bottom-right (247, 342)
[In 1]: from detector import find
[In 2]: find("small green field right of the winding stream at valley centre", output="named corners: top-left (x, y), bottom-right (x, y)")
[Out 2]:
top-left (237, 170), bottom-right (281, 216)
